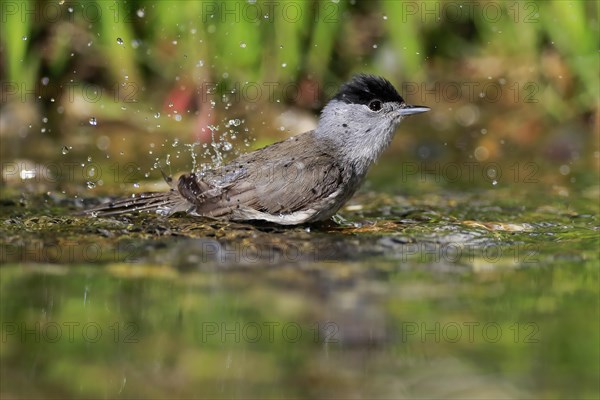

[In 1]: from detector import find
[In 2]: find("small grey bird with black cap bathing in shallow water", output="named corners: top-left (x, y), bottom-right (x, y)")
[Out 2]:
top-left (85, 74), bottom-right (429, 225)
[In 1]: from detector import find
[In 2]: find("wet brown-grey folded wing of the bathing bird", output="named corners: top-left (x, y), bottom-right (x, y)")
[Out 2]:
top-left (179, 132), bottom-right (345, 217)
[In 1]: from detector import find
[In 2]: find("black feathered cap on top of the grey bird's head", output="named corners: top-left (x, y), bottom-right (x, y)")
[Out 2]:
top-left (333, 74), bottom-right (404, 105)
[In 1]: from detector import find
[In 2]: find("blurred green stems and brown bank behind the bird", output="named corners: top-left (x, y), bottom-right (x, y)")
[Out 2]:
top-left (0, 1), bottom-right (600, 194)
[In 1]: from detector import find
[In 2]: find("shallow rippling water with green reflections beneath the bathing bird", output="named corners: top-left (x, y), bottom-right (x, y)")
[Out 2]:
top-left (0, 170), bottom-right (600, 398)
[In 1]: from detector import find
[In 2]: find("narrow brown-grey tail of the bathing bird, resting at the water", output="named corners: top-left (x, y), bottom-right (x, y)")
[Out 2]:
top-left (82, 189), bottom-right (192, 217)
